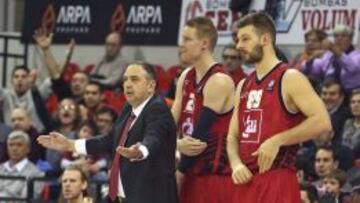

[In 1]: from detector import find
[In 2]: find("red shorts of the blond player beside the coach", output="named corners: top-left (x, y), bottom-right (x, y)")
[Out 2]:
top-left (180, 175), bottom-right (235, 203)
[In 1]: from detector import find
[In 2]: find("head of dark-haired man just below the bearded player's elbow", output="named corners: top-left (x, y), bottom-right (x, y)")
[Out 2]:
top-left (315, 146), bottom-right (339, 178)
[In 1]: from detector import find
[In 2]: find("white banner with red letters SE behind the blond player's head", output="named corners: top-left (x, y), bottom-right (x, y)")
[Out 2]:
top-left (178, 0), bottom-right (240, 44)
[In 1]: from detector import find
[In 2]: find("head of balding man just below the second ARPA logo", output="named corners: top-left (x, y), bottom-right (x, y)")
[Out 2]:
top-left (105, 32), bottom-right (121, 61)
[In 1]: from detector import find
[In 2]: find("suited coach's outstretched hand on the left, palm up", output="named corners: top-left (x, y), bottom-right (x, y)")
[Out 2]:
top-left (37, 132), bottom-right (75, 152)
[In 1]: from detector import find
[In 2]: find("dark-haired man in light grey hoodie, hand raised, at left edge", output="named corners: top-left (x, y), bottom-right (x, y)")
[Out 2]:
top-left (0, 66), bottom-right (52, 132)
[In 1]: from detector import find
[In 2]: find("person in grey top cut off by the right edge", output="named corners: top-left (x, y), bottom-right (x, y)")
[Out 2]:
top-left (341, 89), bottom-right (360, 159)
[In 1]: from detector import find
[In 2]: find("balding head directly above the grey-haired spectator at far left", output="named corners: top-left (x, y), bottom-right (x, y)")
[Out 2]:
top-left (11, 108), bottom-right (31, 132)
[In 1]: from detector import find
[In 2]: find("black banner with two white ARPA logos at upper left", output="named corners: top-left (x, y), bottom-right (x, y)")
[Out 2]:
top-left (22, 0), bottom-right (181, 45)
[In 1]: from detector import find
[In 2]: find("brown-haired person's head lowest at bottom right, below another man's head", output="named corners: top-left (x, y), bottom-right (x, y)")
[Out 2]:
top-left (322, 169), bottom-right (346, 198)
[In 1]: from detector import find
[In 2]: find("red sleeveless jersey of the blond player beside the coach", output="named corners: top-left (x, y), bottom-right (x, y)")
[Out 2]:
top-left (179, 64), bottom-right (232, 174)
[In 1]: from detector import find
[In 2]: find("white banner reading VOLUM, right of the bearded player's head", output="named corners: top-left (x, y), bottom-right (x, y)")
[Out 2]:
top-left (275, 0), bottom-right (360, 44)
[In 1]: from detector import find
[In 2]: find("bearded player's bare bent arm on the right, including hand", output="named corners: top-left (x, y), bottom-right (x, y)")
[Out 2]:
top-left (253, 69), bottom-right (331, 173)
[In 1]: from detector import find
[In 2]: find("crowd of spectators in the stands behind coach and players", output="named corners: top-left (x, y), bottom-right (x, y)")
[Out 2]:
top-left (0, 19), bottom-right (360, 202)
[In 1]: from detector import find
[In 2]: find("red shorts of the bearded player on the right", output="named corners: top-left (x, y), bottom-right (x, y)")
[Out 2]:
top-left (233, 169), bottom-right (300, 203)
